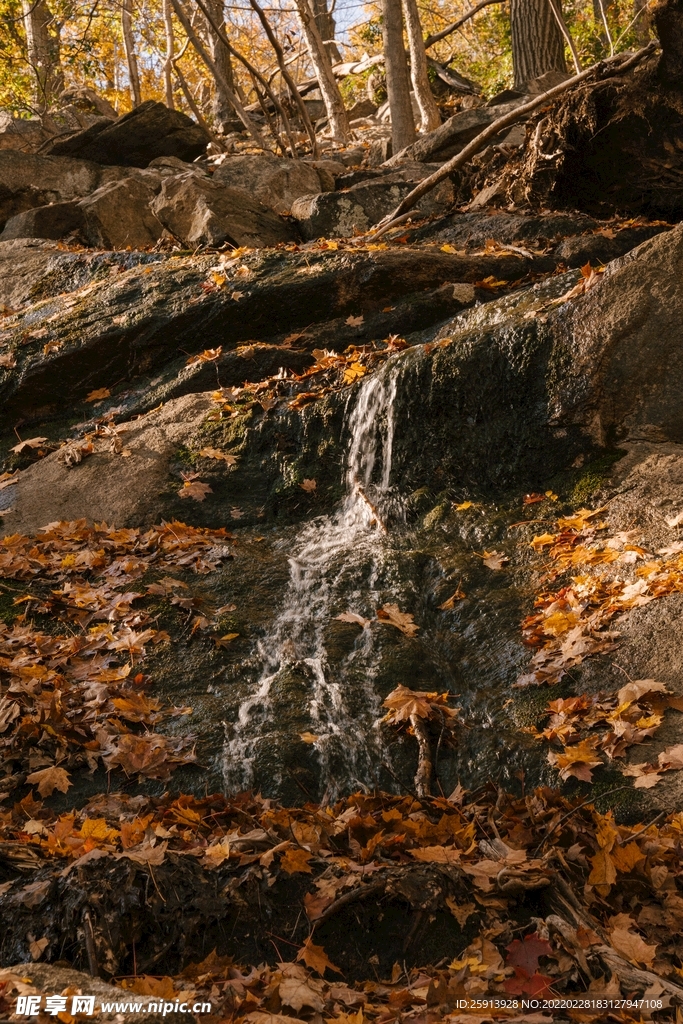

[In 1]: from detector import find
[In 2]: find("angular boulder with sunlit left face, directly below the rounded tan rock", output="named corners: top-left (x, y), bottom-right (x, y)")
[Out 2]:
top-left (152, 173), bottom-right (296, 248)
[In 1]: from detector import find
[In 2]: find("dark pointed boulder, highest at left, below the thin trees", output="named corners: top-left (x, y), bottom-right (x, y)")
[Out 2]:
top-left (47, 99), bottom-right (210, 167)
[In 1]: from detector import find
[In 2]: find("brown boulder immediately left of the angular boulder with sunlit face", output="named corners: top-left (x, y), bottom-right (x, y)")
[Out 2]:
top-left (78, 178), bottom-right (164, 249)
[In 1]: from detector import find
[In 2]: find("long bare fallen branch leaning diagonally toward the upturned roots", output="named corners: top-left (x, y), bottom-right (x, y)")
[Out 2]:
top-left (366, 40), bottom-right (659, 237)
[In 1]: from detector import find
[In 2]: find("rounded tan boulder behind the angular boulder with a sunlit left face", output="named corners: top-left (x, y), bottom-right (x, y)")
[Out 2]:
top-left (213, 153), bottom-right (322, 213)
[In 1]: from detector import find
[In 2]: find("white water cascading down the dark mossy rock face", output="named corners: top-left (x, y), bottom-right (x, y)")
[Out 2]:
top-left (223, 365), bottom-right (397, 798)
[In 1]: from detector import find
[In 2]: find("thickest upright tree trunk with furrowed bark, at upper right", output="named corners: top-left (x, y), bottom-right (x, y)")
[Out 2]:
top-left (510, 0), bottom-right (567, 92)
